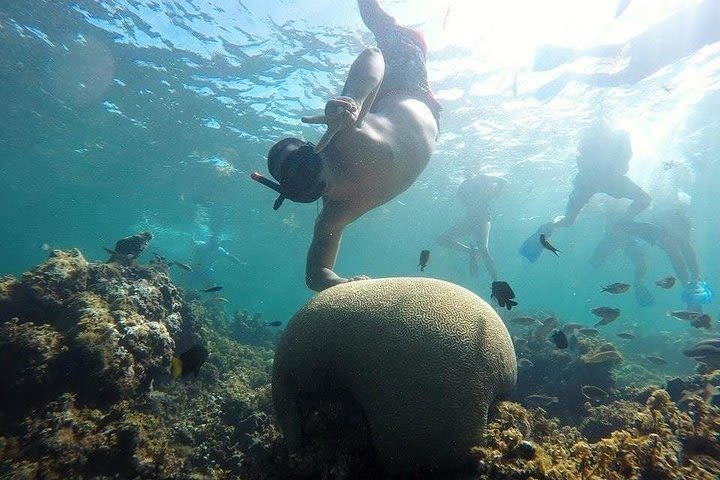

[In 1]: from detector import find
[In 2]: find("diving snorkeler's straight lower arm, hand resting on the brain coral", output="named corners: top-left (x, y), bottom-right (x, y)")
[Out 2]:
top-left (305, 201), bottom-right (368, 292)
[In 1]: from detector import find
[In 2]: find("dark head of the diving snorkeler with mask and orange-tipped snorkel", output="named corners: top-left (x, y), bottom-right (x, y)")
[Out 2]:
top-left (250, 138), bottom-right (325, 210)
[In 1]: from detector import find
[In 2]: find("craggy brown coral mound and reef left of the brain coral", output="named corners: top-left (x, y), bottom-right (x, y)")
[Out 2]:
top-left (0, 250), bottom-right (278, 479)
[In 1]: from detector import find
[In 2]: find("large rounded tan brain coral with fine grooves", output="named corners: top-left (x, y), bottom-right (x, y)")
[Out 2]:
top-left (272, 278), bottom-right (517, 472)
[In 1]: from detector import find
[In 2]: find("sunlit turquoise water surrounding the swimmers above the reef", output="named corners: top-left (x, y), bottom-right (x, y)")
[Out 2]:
top-left (0, 0), bottom-right (720, 373)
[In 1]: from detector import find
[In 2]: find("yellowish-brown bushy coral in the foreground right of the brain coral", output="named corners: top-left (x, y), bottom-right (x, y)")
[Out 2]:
top-left (474, 390), bottom-right (720, 480)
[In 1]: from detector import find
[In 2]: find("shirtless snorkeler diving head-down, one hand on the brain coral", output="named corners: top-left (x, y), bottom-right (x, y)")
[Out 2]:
top-left (252, 0), bottom-right (441, 291)
